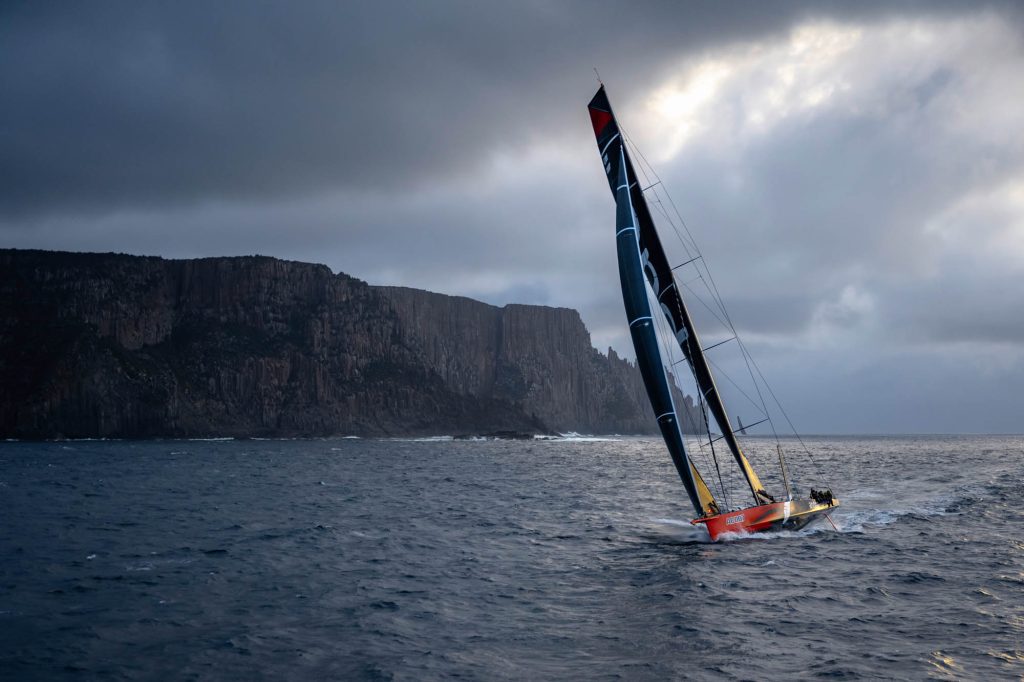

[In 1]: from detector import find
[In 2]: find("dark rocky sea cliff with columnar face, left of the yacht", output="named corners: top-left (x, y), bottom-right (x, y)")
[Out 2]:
top-left (0, 250), bottom-right (700, 438)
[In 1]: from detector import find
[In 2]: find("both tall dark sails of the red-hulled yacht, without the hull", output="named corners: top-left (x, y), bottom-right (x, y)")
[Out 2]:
top-left (588, 85), bottom-right (772, 515)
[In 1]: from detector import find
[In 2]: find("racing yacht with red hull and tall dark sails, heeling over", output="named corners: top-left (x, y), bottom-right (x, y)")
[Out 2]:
top-left (589, 85), bottom-right (839, 541)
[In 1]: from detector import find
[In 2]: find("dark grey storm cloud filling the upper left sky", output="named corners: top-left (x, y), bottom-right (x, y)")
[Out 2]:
top-left (0, 2), bottom-right (995, 217)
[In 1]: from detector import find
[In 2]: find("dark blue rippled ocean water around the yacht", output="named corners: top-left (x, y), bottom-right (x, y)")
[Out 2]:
top-left (0, 436), bottom-right (1024, 680)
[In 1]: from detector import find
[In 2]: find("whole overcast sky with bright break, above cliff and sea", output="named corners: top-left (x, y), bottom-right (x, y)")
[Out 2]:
top-left (0, 1), bottom-right (1024, 433)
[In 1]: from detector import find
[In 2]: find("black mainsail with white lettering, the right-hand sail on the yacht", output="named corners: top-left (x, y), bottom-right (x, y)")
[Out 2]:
top-left (589, 85), bottom-right (771, 504)
